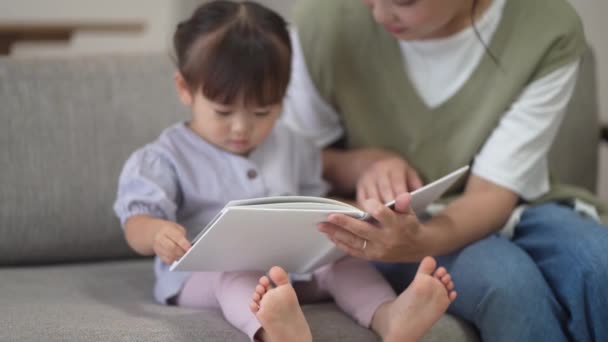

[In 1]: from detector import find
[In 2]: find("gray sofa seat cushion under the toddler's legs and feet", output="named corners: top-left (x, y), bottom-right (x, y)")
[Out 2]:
top-left (0, 260), bottom-right (478, 342)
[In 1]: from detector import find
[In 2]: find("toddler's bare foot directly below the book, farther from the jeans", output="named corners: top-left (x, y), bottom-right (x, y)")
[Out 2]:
top-left (249, 266), bottom-right (312, 342)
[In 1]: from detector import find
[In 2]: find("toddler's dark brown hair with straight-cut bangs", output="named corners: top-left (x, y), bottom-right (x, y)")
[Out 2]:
top-left (173, 0), bottom-right (291, 106)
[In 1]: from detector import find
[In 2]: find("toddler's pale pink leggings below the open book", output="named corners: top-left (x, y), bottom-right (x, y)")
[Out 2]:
top-left (177, 257), bottom-right (396, 341)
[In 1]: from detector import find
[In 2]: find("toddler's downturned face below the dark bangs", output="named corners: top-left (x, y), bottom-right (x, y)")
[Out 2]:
top-left (190, 91), bottom-right (281, 156)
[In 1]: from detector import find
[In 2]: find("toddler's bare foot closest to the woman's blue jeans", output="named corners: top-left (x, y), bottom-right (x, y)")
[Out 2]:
top-left (385, 257), bottom-right (456, 341)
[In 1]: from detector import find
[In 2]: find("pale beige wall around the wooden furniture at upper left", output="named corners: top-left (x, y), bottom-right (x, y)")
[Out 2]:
top-left (0, 0), bottom-right (176, 56)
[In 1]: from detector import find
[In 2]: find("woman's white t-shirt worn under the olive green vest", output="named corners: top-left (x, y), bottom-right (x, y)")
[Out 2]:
top-left (283, 0), bottom-right (579, 200)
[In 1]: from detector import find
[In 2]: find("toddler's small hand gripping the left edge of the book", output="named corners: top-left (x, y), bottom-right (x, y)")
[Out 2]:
top-left (153, 221), bottom-right (191, 265)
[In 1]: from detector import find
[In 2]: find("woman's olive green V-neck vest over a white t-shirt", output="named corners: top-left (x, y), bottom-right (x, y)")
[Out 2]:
top-left (295, 0), bottom-right (608, 218)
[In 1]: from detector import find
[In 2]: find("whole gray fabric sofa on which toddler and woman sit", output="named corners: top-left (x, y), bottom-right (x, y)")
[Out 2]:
top-left (0, 50), bottom-right (597, 341)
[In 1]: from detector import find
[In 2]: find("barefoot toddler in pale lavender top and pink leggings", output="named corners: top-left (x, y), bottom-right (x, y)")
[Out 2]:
top-left (114, 1), bottom-right (456, 341)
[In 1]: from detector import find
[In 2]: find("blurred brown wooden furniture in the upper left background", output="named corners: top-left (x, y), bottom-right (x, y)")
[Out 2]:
top-left (0, 22), bottom-right (145, 56)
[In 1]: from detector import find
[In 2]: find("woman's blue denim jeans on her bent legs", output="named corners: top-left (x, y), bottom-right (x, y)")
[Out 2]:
top-left (376, 203), bottom-right (608, 341)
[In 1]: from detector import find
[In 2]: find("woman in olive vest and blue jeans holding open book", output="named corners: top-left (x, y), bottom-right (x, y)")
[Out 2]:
top-left (285, 0), bottom-right (608, 341)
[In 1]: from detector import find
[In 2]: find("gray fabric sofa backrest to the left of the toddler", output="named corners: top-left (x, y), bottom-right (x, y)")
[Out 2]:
top-left (0, 55), bottom-right (188, 265)
